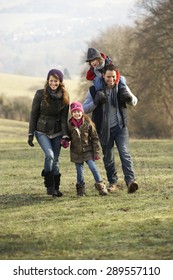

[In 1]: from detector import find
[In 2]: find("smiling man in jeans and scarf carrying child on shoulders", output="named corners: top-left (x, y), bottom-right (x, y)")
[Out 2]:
top-left (83, 64), bottom-right (138, 193)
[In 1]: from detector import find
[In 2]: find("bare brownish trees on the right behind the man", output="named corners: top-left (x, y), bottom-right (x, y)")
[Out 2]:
top-left (80, 0), bottom-right (173, 138)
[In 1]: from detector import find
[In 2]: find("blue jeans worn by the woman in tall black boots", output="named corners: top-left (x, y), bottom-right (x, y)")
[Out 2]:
top-left (35, 132), bottom-right (61, 175)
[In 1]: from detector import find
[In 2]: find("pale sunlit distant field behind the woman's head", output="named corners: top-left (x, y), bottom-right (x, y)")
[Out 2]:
top-left (0, 73), bottom-right (79, 101)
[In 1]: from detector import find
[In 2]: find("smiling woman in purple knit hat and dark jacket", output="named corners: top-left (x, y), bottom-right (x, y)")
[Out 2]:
top-left (28, 69), bottom-right (69, 196)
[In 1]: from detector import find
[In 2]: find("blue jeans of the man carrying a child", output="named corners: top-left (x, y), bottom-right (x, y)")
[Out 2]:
top-left (102, 125), bottom-right (135, 185)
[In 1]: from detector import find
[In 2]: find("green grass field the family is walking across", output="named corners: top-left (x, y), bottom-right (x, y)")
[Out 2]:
top-left (0, 120), bottom-right (173, 260)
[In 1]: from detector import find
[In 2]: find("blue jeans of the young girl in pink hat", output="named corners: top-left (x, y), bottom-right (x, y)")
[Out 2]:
top-left (75, 159), bottom-right (102, 185)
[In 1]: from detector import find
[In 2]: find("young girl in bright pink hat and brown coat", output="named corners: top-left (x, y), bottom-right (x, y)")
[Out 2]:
top-left (69, 102), bottom-right (108, 196)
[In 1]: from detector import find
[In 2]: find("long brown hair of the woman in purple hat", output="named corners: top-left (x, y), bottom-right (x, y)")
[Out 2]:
top-left (43, 75), bottom-right (69, 105)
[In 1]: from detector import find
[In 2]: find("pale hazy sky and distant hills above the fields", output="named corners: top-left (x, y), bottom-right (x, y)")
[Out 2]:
top-left (0, 0), bottom-right (137, 75)
